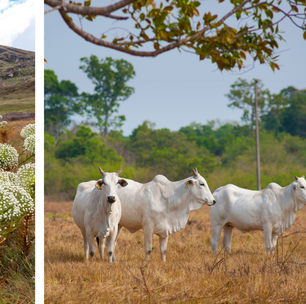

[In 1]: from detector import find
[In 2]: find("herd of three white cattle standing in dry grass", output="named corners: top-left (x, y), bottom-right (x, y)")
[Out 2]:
top-left (72, 168), bottom-right (306, 263)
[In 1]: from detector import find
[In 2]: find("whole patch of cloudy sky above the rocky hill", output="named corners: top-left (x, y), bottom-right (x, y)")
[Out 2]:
top-left (0, 0), bottom-right (36, 51)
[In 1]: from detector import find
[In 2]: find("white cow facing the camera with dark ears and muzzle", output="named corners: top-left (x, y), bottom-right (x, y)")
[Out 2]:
top-left (72, 167), bottom-right (127, 263)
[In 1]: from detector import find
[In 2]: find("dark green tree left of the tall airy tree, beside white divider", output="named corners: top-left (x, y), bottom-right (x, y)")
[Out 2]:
top-left (44, 70), bottom-right (81, 138)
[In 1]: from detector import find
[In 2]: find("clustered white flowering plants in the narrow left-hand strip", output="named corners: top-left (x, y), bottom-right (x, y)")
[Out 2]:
top-left (0, 122), bottom-right (35, 253)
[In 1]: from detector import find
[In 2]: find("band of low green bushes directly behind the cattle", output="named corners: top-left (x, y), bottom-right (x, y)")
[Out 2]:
top-left (45, 121), bottom-right (306, 199)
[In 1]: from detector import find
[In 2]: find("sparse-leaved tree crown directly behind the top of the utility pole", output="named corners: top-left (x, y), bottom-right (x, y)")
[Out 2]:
top-left (225, 78), bottom-right (271, 128)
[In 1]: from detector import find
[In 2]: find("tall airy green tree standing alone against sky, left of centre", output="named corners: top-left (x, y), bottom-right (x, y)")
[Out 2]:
top-left (80, 55), bottom-right (136, 136)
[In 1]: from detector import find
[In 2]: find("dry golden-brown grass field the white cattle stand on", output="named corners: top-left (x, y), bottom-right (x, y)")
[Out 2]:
top-left (45, 202), bottom-right (306, 304)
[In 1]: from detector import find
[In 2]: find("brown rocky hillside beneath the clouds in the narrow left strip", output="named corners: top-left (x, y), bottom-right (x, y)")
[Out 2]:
top-left (0, 45), bottom-right (35, 115)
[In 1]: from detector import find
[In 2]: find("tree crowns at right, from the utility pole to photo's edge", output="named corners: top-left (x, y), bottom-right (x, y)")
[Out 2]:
top-left (226, 78), bottom-right (306, 138)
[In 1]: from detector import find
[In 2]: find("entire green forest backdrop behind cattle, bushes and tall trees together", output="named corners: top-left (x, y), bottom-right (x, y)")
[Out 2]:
top-left (45, 60), bottom-right (306, 200)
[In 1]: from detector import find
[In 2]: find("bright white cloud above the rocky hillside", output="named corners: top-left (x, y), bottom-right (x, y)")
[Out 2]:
top-left (0, 0), bottom-right (35, 49)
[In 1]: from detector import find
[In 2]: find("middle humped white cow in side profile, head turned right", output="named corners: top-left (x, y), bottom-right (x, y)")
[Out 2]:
top-left (93, 169), bottom-right (216, 261)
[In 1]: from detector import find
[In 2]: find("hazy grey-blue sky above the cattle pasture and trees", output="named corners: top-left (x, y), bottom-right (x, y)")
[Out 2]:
top-left (44, 0), bottom-right (306, 135)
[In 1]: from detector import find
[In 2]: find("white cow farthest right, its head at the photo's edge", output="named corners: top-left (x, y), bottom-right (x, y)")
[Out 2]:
top-left (210, 176), bottom-right (306, 254)
